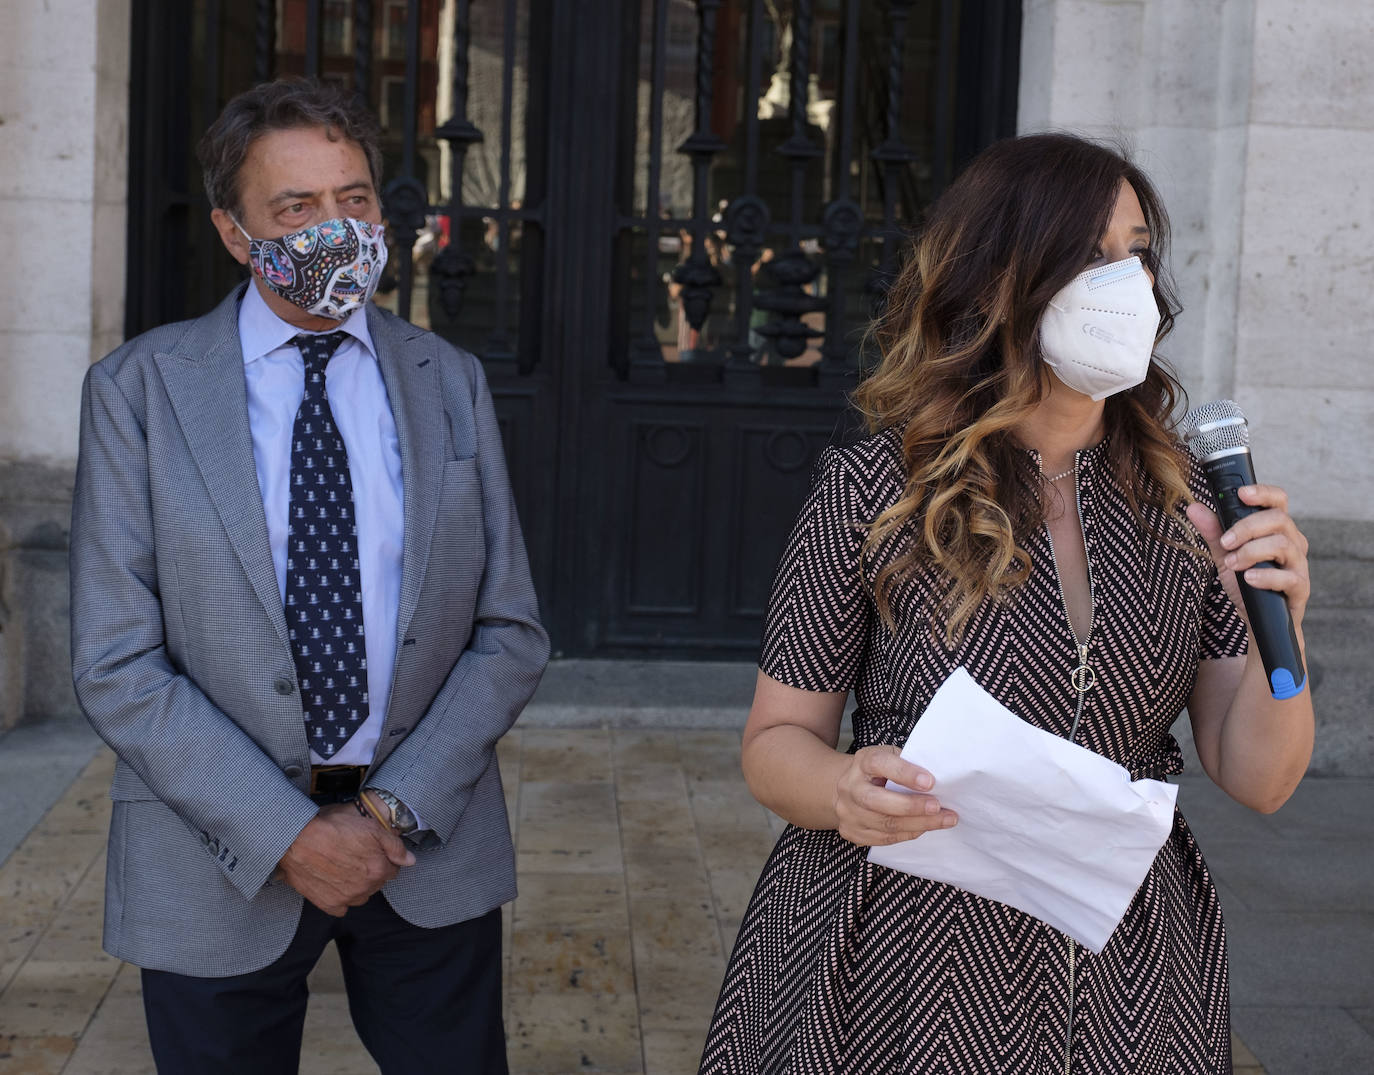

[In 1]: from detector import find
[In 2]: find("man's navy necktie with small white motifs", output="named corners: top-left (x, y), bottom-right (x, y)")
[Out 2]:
top-left (286, 333), bottom-right (368, 757)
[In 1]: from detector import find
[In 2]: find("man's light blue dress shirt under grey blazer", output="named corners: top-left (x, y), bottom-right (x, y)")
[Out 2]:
top-left (239, 283), bottom-right (405, 766)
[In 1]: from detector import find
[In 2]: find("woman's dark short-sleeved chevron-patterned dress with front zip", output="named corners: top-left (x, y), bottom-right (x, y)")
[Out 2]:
top-left (701, 433), bottom-right (1246, 1075)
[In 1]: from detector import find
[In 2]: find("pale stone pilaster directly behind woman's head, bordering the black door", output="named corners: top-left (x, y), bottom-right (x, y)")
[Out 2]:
top-left (1020, 0), bottom-right (1253, 399)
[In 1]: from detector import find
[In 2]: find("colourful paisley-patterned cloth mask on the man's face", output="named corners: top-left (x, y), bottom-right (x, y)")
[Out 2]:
top-left (234, 217), bottom-right (386, 320)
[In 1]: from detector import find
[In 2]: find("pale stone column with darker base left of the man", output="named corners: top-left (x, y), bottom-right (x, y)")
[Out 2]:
top-left (0, 0), bottom-right (129, 729)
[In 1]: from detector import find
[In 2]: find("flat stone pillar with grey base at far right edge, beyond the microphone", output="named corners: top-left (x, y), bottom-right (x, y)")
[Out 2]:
top-left (1234, 0), bottom-right (1374, 777)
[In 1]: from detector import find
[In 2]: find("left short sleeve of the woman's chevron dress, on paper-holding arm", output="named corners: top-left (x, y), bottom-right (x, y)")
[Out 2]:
top-left (758, 448), bottom-right (872, 691)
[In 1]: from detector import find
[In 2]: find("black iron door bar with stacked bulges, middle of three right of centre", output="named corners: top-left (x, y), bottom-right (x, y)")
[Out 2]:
top-left (754, 0), bottom-right (824, 362)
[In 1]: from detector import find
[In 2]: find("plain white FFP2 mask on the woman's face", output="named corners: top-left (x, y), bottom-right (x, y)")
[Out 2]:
top-left (1040, 257), bottom-right (1160, 400)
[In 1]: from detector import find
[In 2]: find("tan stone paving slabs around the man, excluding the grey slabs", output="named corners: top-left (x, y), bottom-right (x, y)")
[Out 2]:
top-left (0, 729), bottom-right (779, 1075)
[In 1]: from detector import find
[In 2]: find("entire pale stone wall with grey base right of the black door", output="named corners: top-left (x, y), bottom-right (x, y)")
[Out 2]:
top-left (1020, 0), bottom-right (1374, 777)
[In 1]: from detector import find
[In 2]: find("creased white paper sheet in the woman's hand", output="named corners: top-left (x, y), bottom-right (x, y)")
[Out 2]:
top-left (868, 668), bottom-right (1178, 953)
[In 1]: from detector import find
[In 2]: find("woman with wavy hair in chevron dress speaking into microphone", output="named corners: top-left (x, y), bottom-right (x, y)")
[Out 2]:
top-left (701, 135), bottom-right (1312, 1075)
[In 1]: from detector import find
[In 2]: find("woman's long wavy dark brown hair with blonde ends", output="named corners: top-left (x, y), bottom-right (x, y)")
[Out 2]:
top-left (855, 133), bottom-right (1191, 646)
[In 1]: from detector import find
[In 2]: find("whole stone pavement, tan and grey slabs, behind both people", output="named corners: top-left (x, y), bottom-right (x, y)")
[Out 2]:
top-left (0, 663), bottom-right (1374, 1075)
